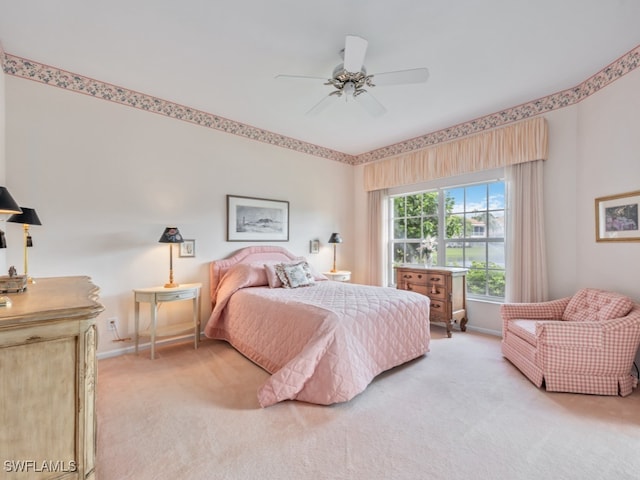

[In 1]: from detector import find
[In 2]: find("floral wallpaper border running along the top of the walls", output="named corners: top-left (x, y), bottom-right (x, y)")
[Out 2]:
top-left (0, 46), bottom-right (640, 165)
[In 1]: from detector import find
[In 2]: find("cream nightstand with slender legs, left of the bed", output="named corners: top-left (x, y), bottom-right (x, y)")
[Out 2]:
top-left (133, 283), bottom-right (202, 360)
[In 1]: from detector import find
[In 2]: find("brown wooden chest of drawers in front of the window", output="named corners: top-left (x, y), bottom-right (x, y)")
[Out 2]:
top-left (396, 266), bottom-right (468, 337)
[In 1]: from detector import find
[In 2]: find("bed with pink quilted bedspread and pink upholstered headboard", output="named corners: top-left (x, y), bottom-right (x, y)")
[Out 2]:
top-left (204, 246), bottom-right (430, 407)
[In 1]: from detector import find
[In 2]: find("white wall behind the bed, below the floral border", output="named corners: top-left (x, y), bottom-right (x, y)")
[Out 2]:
top-left (4, 76), bottom-right (354, 353)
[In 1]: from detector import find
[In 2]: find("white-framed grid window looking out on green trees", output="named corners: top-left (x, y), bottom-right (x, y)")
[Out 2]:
top-left (389, 181), bottom-right (505, 300)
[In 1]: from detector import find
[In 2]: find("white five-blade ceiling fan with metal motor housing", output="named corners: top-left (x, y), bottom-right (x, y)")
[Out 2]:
top-left (276, 35), bottom-right (429, 116)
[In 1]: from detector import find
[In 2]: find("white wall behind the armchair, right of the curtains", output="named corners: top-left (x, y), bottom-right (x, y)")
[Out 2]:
top-left (576, 70), bottom-right (640, 301)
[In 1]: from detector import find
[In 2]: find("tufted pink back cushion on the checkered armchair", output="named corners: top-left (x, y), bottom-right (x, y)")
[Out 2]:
top-left (562, 288), bottom-right (633, 322)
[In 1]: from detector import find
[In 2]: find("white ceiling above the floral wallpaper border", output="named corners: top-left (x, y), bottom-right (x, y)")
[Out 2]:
top-left (0, 0), bottom-right (640, 155)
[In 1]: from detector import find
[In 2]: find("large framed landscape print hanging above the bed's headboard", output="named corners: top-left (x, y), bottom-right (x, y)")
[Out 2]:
top-left (227, 195), bottom-right (289, 242)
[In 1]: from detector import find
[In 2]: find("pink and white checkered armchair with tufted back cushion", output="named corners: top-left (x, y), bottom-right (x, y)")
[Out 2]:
top-left (500, 288), bottom-right (640, 397)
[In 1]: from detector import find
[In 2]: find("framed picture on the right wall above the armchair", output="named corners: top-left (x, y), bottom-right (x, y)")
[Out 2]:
top-left (596, 191), bottom-right (640, 242)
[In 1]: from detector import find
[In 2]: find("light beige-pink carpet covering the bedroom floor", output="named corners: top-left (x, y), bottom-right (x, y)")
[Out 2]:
top-left (97, 326), bottom-right (640, 480)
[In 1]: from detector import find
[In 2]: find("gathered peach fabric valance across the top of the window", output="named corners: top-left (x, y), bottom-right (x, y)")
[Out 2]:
top-left (364, 117), bottom-right (548, 192)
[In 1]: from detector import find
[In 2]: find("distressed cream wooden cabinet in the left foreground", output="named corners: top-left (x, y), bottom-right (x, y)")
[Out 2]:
top-left (0, 277), bottom-right (104, 480)
